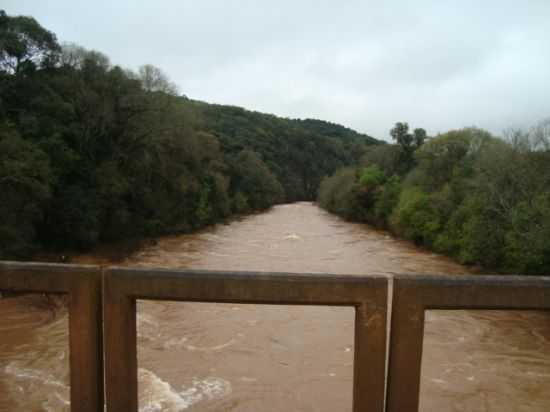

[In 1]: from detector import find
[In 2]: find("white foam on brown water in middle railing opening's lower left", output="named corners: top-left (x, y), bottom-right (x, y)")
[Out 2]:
top-left (138, 368), bottom-right (231, 412)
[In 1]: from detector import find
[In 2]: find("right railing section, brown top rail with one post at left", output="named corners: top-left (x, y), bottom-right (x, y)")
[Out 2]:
top-left (387, 275), bottom-right (550, 412)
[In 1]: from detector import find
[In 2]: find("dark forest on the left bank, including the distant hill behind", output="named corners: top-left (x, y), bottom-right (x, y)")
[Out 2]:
top-left (0, 11), bottom-right (379, 259)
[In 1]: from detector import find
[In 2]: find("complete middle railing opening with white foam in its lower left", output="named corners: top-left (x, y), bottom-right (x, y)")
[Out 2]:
top-left (137, 300), bottom-right (355, 412)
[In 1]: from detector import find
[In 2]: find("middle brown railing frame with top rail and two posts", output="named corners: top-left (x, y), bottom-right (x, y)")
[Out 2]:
top-left (104, 268), bottom-right (388, 412)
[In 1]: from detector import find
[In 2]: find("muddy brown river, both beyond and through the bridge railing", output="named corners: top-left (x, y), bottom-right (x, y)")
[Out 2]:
top-left (0, 203), bottom-right (550, 412)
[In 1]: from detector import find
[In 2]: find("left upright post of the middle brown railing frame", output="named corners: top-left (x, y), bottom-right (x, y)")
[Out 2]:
top-left (104, 272), bottom-right (138, 412)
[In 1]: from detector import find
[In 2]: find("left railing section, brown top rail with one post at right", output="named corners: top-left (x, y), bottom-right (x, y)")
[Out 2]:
top-left (0, 262), bottom-right (104, 412)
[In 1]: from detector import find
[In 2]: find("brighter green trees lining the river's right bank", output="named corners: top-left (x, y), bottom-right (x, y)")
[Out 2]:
top-left (319, 120), bottom-right (550, 275)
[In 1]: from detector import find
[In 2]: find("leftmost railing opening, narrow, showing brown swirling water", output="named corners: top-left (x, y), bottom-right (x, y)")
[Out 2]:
top-left (0, 292), bottom-right (70, 412)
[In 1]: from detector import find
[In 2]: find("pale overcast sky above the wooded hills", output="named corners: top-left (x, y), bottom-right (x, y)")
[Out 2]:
top-left (4, 0), bottom-right (550, 139)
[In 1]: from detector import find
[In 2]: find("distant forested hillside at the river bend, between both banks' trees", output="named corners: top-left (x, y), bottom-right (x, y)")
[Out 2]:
top-left (189, 101), bottom-right (381, 202)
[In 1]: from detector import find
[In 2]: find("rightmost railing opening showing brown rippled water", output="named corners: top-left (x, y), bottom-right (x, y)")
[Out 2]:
top-left (420, 310), bottom-right (550, 412)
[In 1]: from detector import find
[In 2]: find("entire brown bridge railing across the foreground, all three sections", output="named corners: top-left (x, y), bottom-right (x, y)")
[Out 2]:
top-left (0, 262), bottom-right (550, 412)
